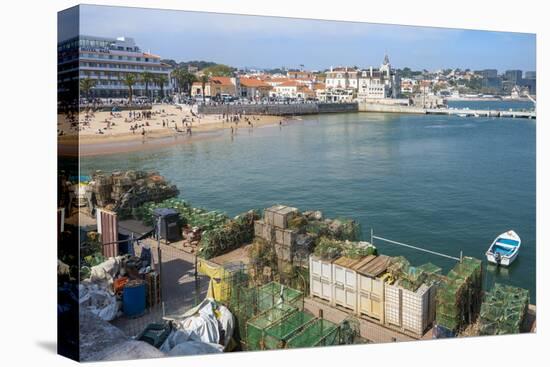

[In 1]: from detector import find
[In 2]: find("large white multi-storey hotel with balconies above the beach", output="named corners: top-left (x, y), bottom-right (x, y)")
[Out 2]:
top-left (74, 35), bottom-right (172, 98)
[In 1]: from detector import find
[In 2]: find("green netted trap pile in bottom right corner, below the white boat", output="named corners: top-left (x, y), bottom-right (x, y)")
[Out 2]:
top-left (479, 283), bottom-right (529, 335)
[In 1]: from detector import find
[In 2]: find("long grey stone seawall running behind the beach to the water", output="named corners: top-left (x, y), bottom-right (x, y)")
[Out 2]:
top-left (198, 103), bottom-right (358, 116)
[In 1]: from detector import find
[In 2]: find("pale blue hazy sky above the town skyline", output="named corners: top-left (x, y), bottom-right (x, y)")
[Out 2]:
top-left (74, 5), bottom-right (536, 72)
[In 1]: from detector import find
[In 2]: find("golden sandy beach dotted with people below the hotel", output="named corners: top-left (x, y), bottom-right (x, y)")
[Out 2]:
top-left (58, 104), bottom-right (285, 156)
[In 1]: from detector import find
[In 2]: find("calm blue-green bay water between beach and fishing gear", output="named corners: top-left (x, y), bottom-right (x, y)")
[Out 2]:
top-left (81, 106), bottom-right (536, 303)
